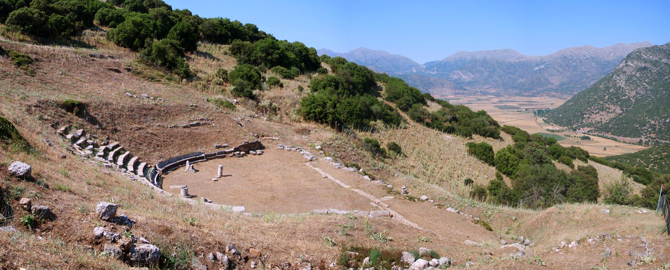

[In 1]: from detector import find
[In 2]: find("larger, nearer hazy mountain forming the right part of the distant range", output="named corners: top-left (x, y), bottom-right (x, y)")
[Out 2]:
top-left (424, 42), bottom-right (652, 95)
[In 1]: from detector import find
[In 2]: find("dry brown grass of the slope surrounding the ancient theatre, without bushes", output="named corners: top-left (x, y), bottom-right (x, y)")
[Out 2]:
top-left (0, 29), bottom-right (668, 268)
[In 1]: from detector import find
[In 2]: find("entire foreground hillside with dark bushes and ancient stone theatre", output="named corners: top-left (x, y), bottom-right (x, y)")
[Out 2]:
top-left (0, 0), bottom-right (670, 270)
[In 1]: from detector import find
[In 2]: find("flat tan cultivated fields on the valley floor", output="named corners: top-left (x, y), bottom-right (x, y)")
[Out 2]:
top-left (439, 96), bottom-right (646, 157)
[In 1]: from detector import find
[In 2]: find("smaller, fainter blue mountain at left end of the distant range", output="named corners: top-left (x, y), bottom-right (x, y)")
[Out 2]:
top-left (318, 47), bottom-right (422, 74)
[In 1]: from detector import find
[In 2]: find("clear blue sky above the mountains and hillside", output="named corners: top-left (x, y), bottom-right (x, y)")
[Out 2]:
top-left (165, 0), bottom-right (670, 63)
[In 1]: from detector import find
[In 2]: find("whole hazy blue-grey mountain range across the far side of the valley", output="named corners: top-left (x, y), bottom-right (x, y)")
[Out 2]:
top-left (318, 41), bottom-right (653, 96)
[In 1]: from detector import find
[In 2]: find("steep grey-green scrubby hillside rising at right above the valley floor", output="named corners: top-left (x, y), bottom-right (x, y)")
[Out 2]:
top-left (547, 44), bottom-right (670, 141)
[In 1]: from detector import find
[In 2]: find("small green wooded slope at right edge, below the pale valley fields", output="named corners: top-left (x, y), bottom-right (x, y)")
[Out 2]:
top-left (605, 144), bottom-right (670, 173)
